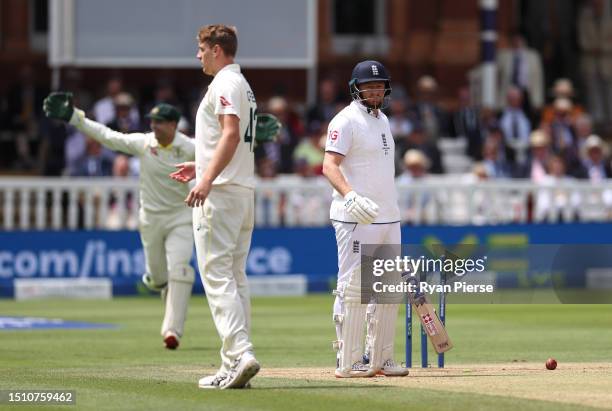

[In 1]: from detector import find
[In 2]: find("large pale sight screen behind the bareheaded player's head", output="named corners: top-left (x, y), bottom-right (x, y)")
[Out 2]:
top-left (51, 0), bottom-right (316, 67)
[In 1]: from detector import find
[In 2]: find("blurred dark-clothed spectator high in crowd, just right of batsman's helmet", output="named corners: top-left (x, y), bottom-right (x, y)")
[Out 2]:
top-left (412, 76), bottom-right (448, 143)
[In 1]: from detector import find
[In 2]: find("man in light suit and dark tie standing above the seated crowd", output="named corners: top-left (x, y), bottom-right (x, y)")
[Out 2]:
top-left (497, 33), bottom-right (544, 117)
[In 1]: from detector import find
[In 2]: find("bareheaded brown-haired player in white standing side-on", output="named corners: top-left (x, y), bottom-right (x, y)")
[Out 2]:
top-left (172, 25), bottom-right (260, 389)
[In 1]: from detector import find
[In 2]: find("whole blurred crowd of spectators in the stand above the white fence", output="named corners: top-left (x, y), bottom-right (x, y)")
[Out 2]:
top-left (0, 0), bottom-right (612, 188)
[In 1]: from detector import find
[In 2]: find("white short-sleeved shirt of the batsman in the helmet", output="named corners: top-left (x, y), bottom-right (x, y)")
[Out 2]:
top-left (325, 101), bottom-right (400, 224)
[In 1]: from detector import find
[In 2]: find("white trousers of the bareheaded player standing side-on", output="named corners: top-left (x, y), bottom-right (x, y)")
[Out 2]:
top-left (193, 185), bottom-right (255, 372)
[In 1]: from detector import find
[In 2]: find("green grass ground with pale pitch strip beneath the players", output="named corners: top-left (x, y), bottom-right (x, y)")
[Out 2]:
top-left (0, 295), bottom-right (612, 411)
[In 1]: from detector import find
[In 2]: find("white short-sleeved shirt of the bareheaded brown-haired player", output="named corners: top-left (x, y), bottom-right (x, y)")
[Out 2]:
top-left (195, 64), bottom-right (257, 188)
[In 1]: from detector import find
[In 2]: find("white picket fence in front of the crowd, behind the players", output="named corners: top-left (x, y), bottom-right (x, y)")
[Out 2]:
top-left (0, 175), bottom-right (612, 230)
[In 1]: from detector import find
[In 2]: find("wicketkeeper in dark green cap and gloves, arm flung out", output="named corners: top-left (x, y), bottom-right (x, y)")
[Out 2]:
top-left (44, 97), bottom-right (195, 349)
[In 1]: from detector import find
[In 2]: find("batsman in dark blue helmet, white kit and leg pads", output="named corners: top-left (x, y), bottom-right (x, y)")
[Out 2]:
top-left (323, 60), bottom-right (408, 378)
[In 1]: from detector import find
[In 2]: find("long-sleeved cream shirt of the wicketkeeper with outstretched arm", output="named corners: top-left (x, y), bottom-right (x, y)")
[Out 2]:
top-left (70, 110), bottom-right (195, 213)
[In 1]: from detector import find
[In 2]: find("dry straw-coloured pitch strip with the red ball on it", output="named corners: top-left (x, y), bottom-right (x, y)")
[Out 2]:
top-left (260, 363), bottom-right (612, 409)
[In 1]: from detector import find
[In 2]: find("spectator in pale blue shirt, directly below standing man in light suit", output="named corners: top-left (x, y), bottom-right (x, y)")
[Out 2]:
top-left (499, 86), bottom-right (531, 166)
